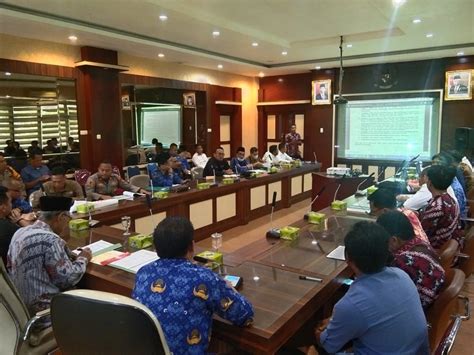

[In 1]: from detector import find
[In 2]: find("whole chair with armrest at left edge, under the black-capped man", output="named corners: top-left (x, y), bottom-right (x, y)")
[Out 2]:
top-left (0, 258), bottom-right (57, 355)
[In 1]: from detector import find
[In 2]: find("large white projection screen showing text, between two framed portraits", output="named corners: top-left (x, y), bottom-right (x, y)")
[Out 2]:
top-left (336, 92), bottom-right (441, 161)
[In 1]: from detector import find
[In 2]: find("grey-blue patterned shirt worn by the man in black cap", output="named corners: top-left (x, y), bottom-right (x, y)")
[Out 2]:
top-left (7, 220), bottom-right (87, 313)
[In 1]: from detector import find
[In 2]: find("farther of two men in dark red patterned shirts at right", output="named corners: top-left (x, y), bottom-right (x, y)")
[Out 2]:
top-left (420, 165), bottom-right (463, 249)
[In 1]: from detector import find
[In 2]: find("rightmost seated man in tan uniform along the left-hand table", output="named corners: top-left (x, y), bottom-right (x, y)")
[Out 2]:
top-left (86, 161), bottom-right (149, 201)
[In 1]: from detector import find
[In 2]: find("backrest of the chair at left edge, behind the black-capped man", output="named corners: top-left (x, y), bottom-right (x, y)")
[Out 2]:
top-left (0, 259), bottom-right (29, 354)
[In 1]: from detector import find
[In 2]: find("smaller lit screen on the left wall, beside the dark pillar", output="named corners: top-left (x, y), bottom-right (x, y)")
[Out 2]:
top-left (139, 105), bottom-right (182, 147)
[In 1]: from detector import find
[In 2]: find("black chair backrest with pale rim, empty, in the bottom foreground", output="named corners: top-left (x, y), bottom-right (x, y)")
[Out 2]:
top-left (51, 290), bottom-right (170, 355)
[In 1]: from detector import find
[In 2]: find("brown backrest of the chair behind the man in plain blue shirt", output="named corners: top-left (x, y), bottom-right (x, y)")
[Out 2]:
top-left (426, 269), bottom-right (466, 349)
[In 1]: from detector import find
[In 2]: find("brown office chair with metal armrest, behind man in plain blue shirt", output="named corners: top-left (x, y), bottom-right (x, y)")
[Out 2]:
top-left (426, 269), bottom-right (470, 354)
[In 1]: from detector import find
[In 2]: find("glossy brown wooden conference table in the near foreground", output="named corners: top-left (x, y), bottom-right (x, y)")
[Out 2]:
top-left (68, 193), bottom-right (371, 354)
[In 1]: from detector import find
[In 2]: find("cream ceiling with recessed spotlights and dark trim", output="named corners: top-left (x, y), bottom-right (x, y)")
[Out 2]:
top-left (0, 0), bottom-right (474, 76)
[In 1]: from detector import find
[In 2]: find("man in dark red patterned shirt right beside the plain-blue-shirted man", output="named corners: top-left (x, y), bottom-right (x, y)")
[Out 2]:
top-left (377, 211), bottom-right (445, 309)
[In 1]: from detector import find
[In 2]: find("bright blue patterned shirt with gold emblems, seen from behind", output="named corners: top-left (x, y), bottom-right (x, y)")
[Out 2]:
top-left (132, 258), bottom-right (253, 355)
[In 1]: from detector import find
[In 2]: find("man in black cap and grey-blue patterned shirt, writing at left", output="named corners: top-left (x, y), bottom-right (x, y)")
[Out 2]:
top-left (7, 196), bottom-right (92, 327)
